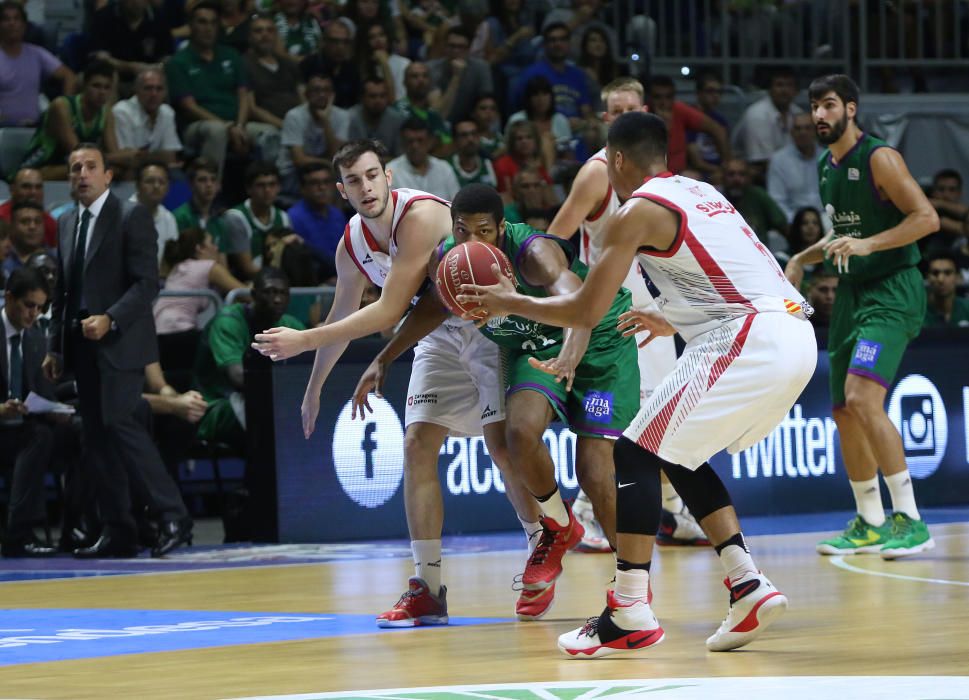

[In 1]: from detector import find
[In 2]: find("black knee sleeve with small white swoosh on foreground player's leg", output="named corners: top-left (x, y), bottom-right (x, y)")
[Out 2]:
top-left (612, 437), bottom-right (663, 536)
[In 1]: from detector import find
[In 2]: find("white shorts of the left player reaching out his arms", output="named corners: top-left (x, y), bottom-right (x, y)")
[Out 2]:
top-left (404, 320), bottom-right (505, 437)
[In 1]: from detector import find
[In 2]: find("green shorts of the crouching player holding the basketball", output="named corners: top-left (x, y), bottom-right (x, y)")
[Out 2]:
top-left (505, 333), bottom-right (639, 438)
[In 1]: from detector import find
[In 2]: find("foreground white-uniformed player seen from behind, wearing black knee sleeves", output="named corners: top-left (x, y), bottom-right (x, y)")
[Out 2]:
top-left (458, 112), bottom-right (817, 659)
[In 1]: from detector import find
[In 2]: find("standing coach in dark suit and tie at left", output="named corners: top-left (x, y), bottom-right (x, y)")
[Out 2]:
top-left (44, 144), bottom-right (192, 557)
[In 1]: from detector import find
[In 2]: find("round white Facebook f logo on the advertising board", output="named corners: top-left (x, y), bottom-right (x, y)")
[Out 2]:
top-left (333, 395), bottom-right (404, 508)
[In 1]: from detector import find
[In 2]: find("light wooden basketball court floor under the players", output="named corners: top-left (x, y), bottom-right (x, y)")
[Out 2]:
top-left (0, 523), bottom-right (969, 700)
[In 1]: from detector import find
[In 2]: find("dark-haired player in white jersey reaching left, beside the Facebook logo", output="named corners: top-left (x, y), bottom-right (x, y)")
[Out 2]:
top-left (253, 140), bottom-right (542, 627)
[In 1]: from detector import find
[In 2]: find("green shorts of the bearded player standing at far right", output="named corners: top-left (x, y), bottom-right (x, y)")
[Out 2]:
top-left (828, 267), bottom-right (925, 407)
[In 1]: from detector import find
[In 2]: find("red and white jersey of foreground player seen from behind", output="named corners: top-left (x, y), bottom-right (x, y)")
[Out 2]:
top-left (625, 173), bottom-right (810, 341)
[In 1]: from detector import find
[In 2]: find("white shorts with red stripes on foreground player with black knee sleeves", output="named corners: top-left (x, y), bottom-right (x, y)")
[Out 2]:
top-left (623, 313), bottom-right (818, 469)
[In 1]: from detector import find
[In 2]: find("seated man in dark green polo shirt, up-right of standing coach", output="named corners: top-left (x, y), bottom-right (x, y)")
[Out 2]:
top-left (165, 0), bottom-right (271, 174)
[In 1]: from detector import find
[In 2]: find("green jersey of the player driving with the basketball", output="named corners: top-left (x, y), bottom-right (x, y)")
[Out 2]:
top-left (441, 224), bottom-right (632, 353)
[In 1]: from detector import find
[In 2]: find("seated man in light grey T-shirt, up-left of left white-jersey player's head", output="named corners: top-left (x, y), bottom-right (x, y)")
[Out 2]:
top-left (276, 73), bottom-right (350, 195)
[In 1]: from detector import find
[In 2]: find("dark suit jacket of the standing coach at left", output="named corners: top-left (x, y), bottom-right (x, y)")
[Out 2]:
top-left (50, 194), bottom-right (158, 371)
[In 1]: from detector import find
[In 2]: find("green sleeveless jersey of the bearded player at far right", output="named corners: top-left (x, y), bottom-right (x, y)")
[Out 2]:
top-left (818, 134), bottom-right (921, 282)
